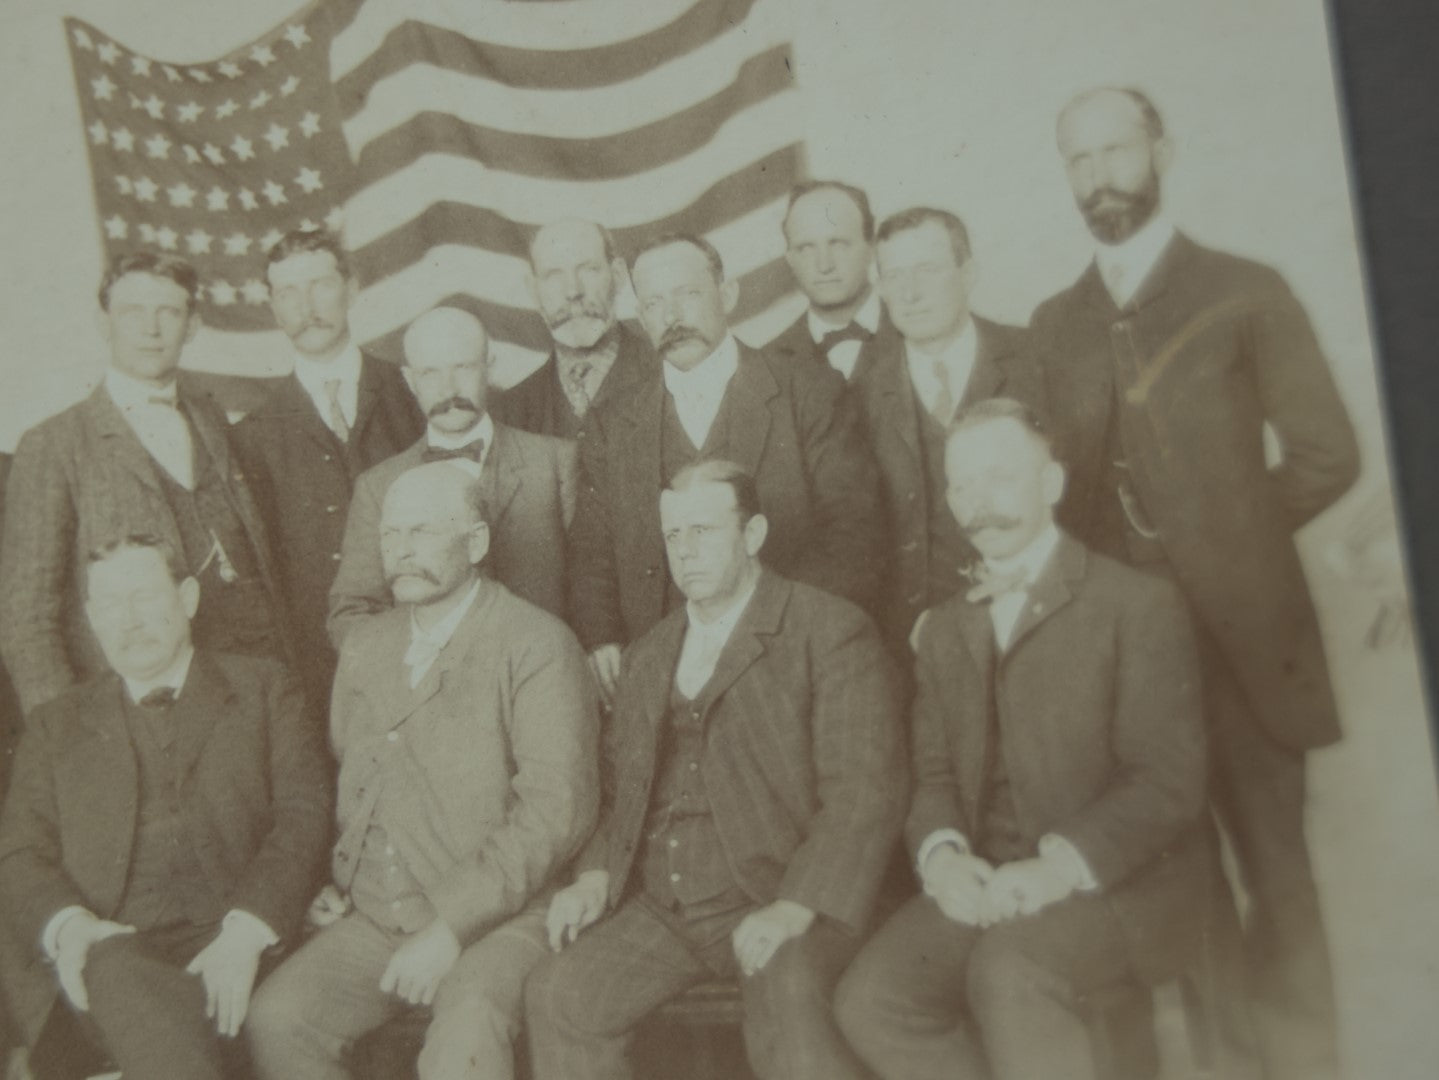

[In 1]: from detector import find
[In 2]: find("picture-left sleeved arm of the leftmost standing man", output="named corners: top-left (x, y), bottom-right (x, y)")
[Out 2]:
top-left (0, 424), bottom-right (78, 713)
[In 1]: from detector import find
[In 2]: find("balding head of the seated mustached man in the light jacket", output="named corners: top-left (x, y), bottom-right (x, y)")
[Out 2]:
top-left (380, 462), bottom-right (489, 611)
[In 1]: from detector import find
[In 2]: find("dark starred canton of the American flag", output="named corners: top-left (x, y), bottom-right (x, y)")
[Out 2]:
top-left (65, 9), bottom-right (353, 329)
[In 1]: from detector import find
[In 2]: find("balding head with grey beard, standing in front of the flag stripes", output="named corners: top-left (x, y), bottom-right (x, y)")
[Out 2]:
top-left (530, 217), bottom-right (625, 349)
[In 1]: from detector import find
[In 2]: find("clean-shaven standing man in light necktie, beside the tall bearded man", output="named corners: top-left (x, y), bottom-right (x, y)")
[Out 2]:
top-left (855, 207), bottom-right (1042, 656)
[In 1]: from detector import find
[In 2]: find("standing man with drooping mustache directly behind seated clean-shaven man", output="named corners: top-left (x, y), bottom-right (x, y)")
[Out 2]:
top-left (570, 236), bottom-right (879, 700)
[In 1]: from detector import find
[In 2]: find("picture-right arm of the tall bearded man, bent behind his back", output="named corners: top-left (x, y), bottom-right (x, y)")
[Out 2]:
top-left (1246, 272), bottom-right (1360, 528)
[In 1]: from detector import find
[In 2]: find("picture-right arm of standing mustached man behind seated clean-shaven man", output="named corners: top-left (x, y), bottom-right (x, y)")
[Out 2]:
top-left (790, 364), bottom-right (881, 607)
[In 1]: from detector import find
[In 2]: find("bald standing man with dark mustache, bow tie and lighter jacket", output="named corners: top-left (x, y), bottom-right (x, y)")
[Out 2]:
top-left (330, 306), bottom-right (576, 649)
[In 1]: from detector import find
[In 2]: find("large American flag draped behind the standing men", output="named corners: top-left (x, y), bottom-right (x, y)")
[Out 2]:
top-left (65, 0), bottom-right (803, 383)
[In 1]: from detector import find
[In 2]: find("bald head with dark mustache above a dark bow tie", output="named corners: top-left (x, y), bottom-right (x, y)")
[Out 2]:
top-left (404, 308), bottom-right (489, 436)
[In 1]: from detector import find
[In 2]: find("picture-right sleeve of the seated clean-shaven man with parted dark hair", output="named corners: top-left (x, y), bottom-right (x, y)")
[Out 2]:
top-left (778, 604), bottom-right (909, 928)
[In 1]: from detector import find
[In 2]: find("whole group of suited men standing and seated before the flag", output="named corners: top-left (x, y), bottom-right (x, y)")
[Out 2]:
top-left (0, 88), bottom-right (1358, 1080)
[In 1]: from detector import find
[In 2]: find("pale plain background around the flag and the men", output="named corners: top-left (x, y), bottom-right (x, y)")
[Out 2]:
top-left (0, 0), bottom-right (1439, 1080)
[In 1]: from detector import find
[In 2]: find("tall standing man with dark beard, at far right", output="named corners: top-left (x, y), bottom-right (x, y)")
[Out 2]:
top-left (1033, 88), bottom-right (1358, 1079)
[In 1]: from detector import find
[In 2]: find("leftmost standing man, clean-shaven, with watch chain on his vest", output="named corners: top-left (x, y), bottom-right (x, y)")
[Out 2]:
top-left (0, 252), bottom-right (289, 713)
